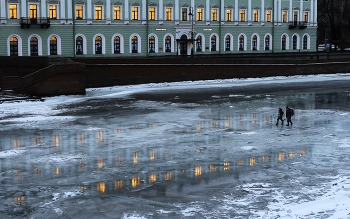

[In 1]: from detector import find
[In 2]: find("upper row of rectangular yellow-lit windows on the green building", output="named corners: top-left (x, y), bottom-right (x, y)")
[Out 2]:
top-left (9, 4), bottom-right (309, 22)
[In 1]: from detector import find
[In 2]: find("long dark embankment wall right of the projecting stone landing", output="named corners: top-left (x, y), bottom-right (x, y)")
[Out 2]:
top-left (73, 54), bottom-right (350, 88)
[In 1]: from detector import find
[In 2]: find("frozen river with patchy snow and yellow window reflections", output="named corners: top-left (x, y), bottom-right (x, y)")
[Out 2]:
top-left (0, 74), bottom-right (350, 219)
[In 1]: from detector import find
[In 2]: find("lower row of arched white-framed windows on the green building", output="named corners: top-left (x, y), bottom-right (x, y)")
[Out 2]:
top-left (8, 34), bottom-right (310, 56)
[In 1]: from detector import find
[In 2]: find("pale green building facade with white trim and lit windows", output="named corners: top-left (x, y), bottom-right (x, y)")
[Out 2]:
top-left (0, 0), bottom-right (317, 57)
